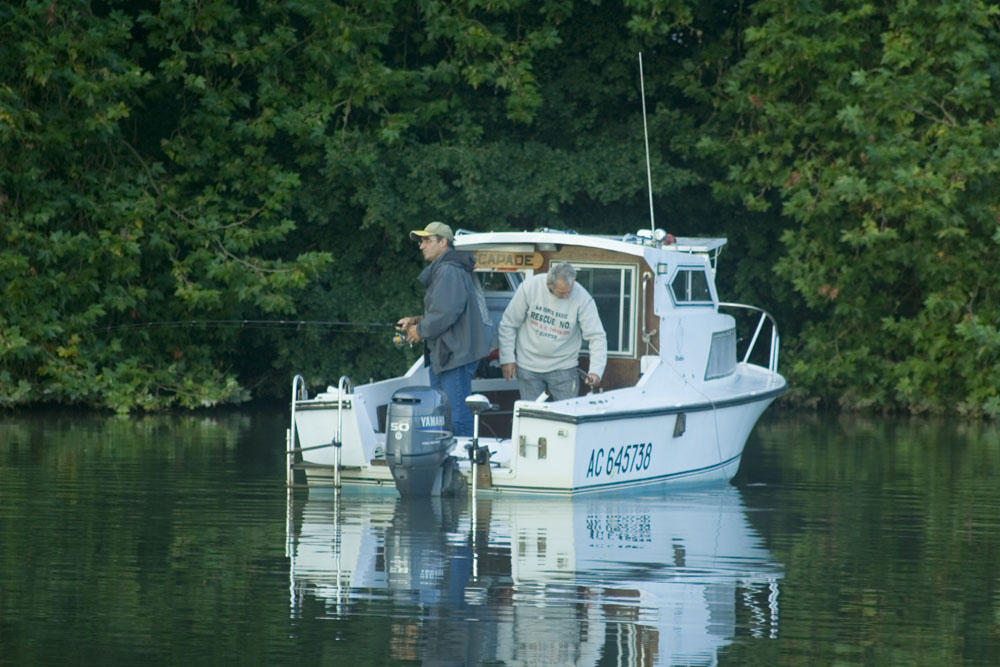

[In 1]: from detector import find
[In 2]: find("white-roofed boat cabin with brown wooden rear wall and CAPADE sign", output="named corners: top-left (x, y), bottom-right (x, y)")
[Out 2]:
top-left (455, 230), bottom-right (735, 444)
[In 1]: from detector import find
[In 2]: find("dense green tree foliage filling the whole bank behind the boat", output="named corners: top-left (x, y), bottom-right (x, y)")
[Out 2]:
top-left (0, 0), bottom-right (1000, 415)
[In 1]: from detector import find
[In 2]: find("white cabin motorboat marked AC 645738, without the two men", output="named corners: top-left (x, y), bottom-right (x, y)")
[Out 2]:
top-left (288, 230), bottom-right (786, 494)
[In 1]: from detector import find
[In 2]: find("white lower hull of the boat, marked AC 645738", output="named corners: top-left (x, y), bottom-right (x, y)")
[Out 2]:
top-left (297, 384), bottom-right (780, 495)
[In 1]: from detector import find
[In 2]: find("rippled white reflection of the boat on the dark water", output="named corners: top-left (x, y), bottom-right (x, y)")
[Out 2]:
top-left (287, 486), bottom-right (782, 665)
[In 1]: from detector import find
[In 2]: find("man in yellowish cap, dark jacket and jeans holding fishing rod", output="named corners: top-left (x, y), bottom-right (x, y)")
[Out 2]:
top-left (396, 222), bottom-right (492, 436)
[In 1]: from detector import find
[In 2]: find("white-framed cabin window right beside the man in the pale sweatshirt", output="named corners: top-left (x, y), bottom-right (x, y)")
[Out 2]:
top-left (573, 262), bottom-right (636, 356)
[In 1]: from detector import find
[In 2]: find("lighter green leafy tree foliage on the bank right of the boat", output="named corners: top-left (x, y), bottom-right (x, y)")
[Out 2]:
top-left (703, 1), bottom-right (1000, 415)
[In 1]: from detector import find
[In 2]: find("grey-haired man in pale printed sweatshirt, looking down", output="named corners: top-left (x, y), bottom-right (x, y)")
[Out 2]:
top-left (499, 262), bottom-right (608, 401)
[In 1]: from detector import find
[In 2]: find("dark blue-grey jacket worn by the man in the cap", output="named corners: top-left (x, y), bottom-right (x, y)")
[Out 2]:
top-left (417, 248), bottom-right (493, 374)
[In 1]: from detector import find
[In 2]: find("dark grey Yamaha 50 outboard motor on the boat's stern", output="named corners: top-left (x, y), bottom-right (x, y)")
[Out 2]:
top-left (385, 387), bottom-right (465, 497)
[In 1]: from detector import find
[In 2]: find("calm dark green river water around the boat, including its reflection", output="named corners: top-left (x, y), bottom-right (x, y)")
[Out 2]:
top-left (0, 412), bottom-right (1000, 667)
